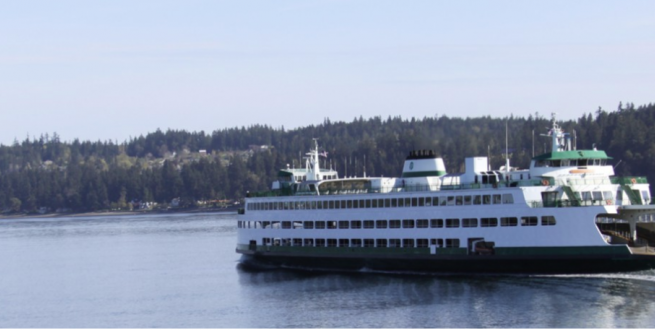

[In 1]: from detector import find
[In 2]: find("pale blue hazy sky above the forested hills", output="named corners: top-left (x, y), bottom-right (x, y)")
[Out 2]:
top-left (0, 0), bottom-right (655, 145)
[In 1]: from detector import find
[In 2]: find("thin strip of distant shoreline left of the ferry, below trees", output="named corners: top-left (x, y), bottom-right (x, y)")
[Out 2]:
top-left (0, 208), bottom-right (237, 221)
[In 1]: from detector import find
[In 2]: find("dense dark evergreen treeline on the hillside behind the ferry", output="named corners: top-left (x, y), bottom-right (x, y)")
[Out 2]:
top-left (0, 103), bottom-right (655, 212)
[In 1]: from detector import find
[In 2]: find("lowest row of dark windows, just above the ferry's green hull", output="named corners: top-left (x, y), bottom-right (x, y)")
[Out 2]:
top-left (263, 238), bottom-right (459, 248)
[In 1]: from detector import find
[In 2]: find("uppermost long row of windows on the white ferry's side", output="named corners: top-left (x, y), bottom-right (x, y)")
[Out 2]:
top-left (247, 194), bottom-right (514, 211)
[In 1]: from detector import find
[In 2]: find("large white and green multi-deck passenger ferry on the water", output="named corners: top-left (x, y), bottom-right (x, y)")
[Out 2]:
top-left (236, 115), bottom-right (655, 274)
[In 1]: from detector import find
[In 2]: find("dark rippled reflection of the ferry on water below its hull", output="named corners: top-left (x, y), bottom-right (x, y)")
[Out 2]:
top-left (238, 268), bottom-right (655, 328)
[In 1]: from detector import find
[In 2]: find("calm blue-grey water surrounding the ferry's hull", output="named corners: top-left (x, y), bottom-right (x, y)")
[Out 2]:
top-left (0, 214), bottom-right (655, 328)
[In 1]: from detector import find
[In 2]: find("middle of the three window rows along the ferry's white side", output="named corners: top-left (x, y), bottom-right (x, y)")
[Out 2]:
top-left (238, 215), bottom-right (557, 229)
